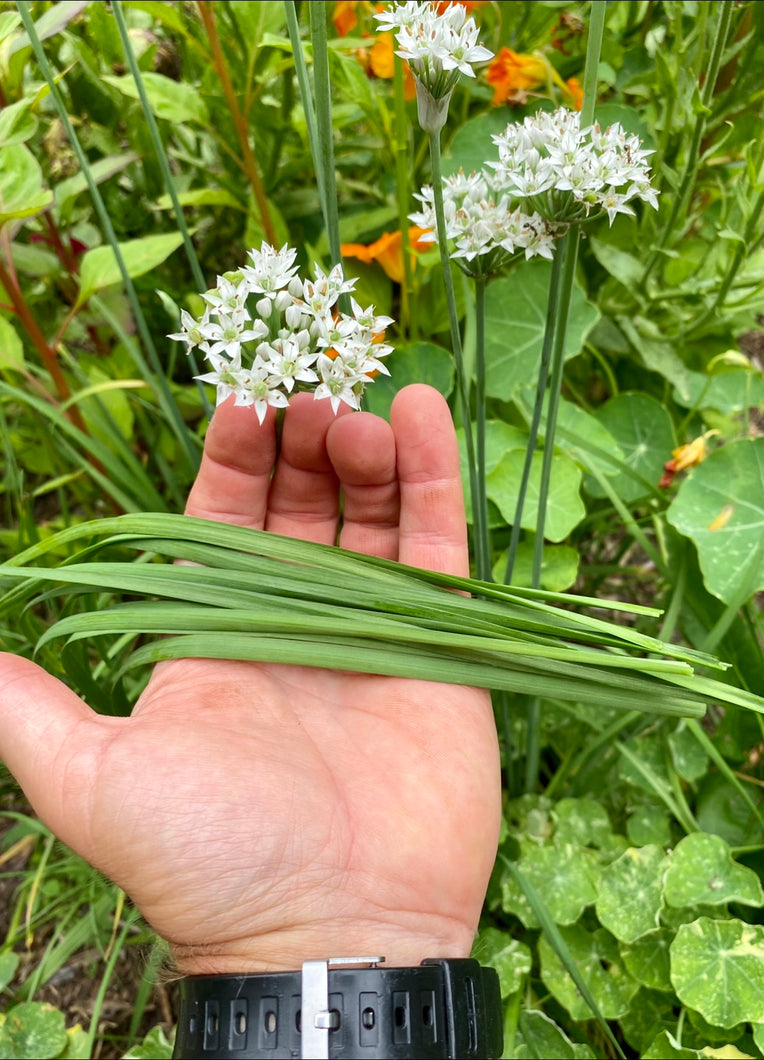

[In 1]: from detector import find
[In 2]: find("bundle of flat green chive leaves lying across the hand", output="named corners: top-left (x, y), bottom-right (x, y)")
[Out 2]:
top-left (0, 513), bottom-right (764, 717)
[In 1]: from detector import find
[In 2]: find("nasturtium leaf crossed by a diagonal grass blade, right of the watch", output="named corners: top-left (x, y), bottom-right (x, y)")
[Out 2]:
top-left (538, 924), bottom-right (639, 1020)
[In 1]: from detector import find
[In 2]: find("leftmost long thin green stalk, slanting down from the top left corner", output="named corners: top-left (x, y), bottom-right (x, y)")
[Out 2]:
top-left (17, 0), bottom-right (198, 473)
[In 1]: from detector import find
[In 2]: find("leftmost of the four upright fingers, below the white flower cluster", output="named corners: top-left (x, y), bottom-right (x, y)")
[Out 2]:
top-left (185, 398), bottom-right (276, 530)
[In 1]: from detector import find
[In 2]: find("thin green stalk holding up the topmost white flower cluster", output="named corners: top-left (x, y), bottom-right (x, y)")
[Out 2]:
top-left (428, 131), bottom-right (491, 589)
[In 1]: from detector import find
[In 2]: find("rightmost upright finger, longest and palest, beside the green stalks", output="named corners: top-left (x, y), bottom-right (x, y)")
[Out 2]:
top-left (390, 384), bottom-right (469, 577)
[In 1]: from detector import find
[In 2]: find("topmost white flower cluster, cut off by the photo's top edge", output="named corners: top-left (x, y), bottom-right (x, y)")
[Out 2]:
top-left (374, 0), bottom-right (494, 100)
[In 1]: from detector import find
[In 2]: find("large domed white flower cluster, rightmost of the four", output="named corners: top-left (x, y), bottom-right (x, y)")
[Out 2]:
top-left (490, 107), bottom-right (658, 224)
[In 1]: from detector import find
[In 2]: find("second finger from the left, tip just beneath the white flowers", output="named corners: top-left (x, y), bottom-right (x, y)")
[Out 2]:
top-left (265, 394), bottom-right (350, 545)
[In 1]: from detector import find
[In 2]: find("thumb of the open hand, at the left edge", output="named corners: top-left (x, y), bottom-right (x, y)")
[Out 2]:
top-left (0, 652), bottom-right (116, 858)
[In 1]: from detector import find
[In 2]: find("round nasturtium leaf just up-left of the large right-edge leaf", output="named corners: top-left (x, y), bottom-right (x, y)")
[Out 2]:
top-left (586, 392), bottom-right (676, 504)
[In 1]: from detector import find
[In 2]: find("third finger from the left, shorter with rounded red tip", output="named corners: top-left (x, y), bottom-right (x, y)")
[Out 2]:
top-left (326, 412), bottom-right (399, 560)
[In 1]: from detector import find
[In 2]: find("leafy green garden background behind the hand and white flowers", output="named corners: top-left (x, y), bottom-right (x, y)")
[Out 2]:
top-left (0, 0), bottom-right (764, 1057)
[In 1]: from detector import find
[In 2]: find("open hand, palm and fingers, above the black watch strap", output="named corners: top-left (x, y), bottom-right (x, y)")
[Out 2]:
top-left (0, 385), bottom-right (500, 974)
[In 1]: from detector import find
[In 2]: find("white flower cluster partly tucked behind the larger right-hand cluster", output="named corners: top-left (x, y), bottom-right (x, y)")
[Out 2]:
top-left (410, 170), bottom-right (554, 276)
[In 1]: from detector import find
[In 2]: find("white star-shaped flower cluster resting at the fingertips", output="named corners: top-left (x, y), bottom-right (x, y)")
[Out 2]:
top-left (168, 243), bottom-right (393, 423)
